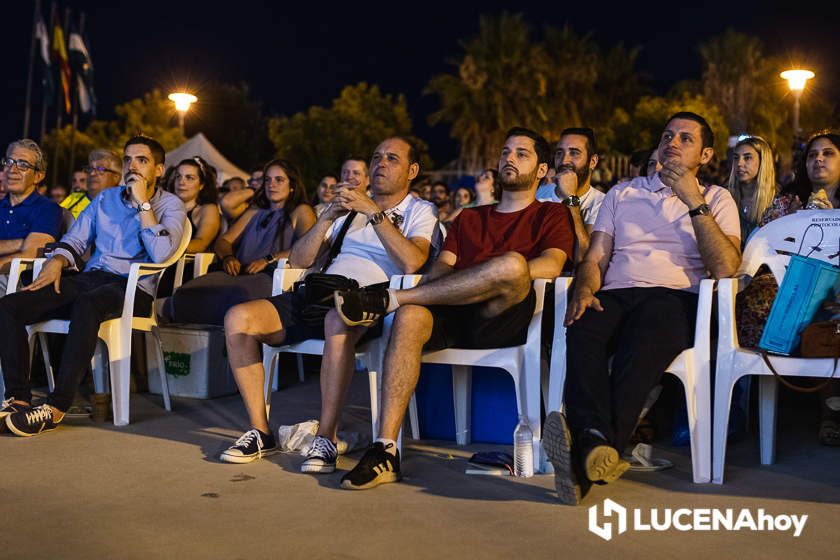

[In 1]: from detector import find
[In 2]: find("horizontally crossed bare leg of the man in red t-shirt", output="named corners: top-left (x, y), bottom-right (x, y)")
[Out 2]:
top-left (396, 252), bottom-right (531, 317)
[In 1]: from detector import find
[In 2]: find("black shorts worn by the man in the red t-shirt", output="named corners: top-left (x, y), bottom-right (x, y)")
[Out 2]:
top-left (423, 287), bottom-right (537, 351)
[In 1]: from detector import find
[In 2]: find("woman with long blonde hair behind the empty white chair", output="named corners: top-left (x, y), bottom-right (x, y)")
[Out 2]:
top-left (729, 136), bottom-right (777, 244)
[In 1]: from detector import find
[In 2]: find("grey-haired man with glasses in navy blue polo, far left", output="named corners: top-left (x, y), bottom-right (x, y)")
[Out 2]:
top-left (0, 139), bottom-right (61, 296)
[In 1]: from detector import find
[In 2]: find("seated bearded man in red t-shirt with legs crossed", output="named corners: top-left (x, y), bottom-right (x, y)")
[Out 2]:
top-left (335, 128), bottom-right (575, 490)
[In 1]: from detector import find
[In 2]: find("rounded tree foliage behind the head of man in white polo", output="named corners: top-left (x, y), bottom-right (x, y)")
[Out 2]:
top-left (268, 82), bottom-right (428, 193)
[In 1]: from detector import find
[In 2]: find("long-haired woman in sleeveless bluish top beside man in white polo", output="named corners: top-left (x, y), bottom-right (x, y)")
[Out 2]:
top-left (170, 159), bottom-right (316, 325)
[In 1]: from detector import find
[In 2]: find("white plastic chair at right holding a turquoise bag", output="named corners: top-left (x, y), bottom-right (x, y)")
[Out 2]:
top-left (712, 210), bottom-right (840, 484)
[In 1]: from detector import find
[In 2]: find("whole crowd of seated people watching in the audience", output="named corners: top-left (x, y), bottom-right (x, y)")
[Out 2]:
top-left (0, 108), bottom-right (840, 504)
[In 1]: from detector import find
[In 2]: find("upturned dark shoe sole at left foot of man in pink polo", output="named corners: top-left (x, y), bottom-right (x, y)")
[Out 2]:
top-left (542, 412), bottom-right (592, 506)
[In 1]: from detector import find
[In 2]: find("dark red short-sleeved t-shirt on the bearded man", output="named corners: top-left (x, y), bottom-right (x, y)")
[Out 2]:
top-left (442, 201), bottom-right (575, 269)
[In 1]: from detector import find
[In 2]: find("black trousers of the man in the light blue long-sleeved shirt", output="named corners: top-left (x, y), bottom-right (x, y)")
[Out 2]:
top-left (0, 270), bottom-right (153, 411)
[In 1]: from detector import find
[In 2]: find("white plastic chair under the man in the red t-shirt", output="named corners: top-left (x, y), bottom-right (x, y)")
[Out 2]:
top-left (371, 275), bottom-right (562, 472)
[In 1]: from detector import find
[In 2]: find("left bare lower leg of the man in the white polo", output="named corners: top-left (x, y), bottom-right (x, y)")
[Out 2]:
top-left (225, 299), bottom-right (286, 434)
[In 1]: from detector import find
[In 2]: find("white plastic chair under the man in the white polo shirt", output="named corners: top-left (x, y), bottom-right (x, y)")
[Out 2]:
top-left (263, 259), bottom-right (419, 439)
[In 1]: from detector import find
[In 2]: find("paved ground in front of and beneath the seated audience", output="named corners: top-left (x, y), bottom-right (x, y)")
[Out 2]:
top-left (0, 376), bottom-right (840, 560)
